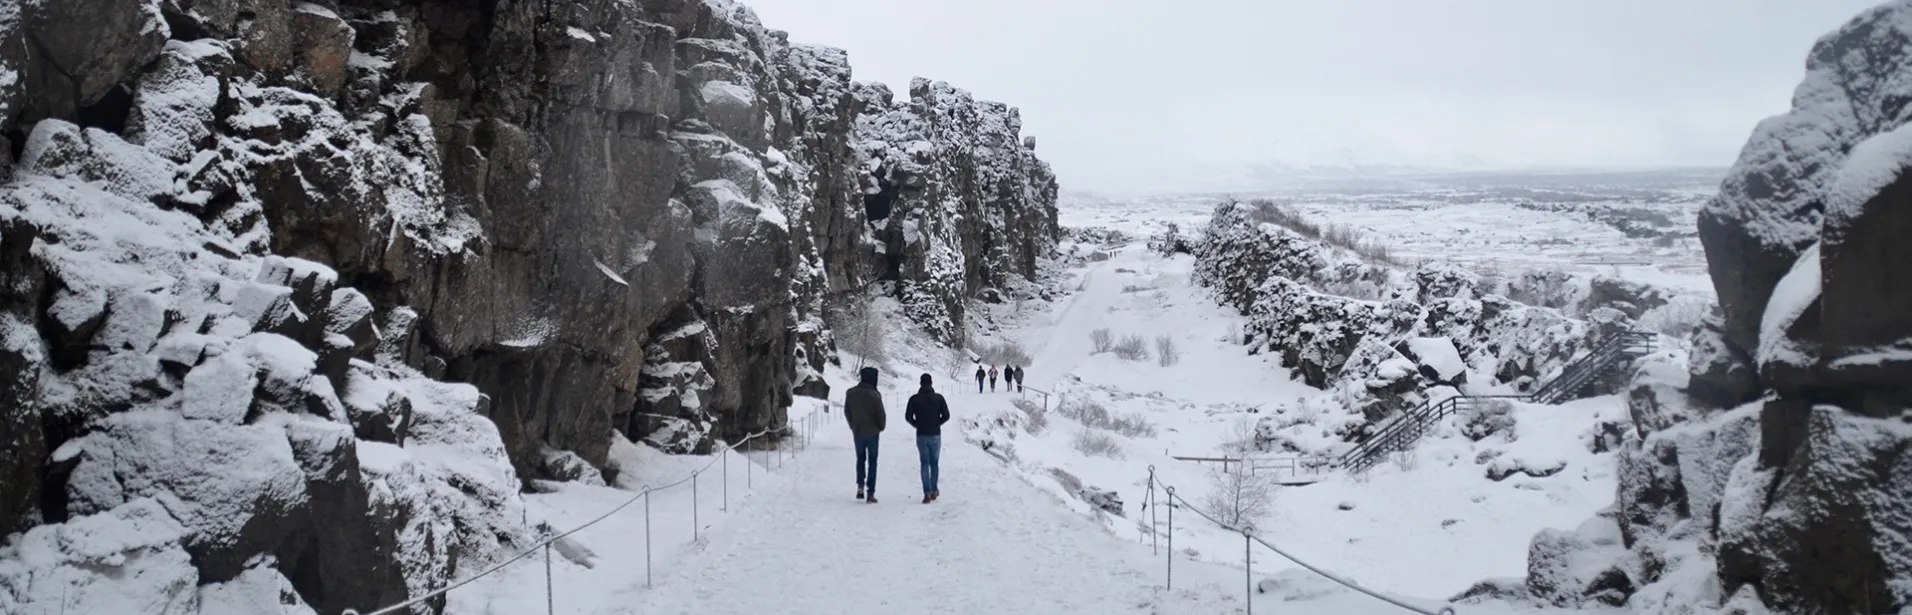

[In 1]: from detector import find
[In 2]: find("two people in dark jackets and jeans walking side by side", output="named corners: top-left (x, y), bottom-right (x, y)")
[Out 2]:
top-left (843, 367), bottom-right (950, 504)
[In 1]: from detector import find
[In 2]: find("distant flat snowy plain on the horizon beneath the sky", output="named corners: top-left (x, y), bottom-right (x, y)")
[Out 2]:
top-left (1061, 176), bottom-right (1717, 298)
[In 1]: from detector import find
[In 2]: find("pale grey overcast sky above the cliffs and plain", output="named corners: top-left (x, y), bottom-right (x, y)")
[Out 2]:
top-left (744, 0), bottom-right (1878, 193)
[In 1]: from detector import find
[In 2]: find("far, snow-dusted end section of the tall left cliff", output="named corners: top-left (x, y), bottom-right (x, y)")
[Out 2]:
top-left (855, 78), bottom-right (1061, 346)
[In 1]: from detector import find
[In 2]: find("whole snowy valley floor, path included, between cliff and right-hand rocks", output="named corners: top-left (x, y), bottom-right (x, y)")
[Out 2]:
top-left (449, 195), bottom-right (1659, 615)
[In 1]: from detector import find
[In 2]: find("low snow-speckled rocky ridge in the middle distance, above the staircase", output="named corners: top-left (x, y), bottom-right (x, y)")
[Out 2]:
top-left (1195, 202), bottom-right (1631, 420)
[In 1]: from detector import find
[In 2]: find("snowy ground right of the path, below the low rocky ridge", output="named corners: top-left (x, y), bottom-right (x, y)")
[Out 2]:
top-left (954, 240), bottom-right (1625, 598)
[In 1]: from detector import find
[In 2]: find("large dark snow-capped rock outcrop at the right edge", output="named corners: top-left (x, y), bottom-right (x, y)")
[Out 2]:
top-left (1499, 0), bottom-right (1912, 613)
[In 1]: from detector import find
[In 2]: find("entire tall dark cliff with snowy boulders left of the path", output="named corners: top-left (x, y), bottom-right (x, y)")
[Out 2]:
top-left (0, 0), bottom-right (1057, 613)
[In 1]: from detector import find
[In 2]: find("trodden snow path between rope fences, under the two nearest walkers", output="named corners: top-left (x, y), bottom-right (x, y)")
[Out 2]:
top-left (629, 412), bottom-right (1159, 615)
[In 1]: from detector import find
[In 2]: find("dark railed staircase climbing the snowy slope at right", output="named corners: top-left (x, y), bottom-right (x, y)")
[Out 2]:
top-left (1340, 330), bottom-right (1654, 474)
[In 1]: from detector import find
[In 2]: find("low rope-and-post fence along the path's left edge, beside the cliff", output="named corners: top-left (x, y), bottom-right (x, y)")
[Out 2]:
top-left (342, 411), bottom-right (822, 615)
